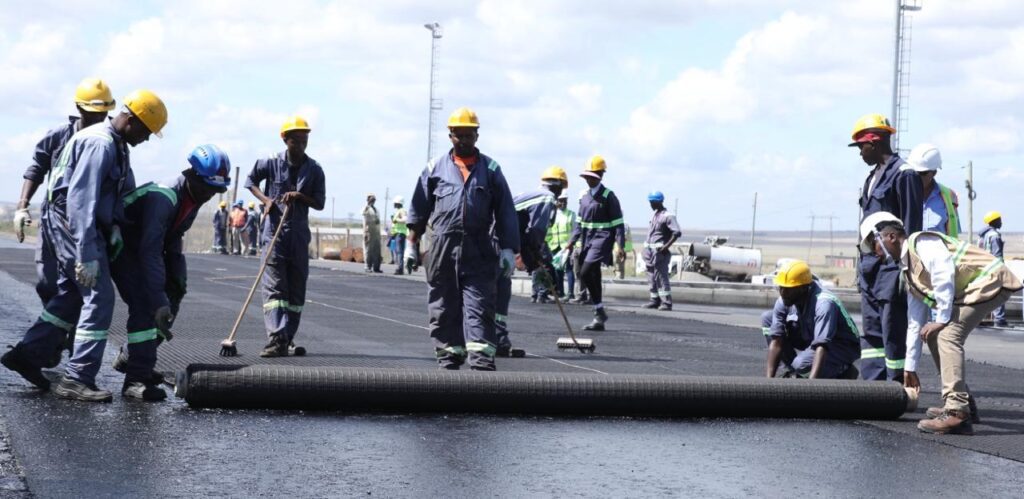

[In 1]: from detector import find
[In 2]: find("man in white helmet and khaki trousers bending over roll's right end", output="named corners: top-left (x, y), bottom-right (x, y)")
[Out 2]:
top-left (860, 212), bottom-right (1024, 434)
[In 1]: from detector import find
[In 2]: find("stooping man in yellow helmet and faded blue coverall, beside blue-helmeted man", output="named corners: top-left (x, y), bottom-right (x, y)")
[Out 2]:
top-left (2, 90), bottom-right (167, 402)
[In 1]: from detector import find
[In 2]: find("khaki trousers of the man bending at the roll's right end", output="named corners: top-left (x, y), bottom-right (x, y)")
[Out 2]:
top-left (928, 290), bottom-right (1013, 413)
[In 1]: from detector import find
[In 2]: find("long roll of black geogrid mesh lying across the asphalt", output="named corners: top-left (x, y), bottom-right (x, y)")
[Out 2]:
top-left (175, 364), bottom-right (916, 419)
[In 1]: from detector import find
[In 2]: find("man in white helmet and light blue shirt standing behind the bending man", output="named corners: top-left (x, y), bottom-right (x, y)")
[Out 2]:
top-left (900, 143), bottom-right (961, 387)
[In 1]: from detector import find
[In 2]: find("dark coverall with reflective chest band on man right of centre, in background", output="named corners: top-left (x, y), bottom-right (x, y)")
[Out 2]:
top-left (569, 183), bottom-right (626, 308)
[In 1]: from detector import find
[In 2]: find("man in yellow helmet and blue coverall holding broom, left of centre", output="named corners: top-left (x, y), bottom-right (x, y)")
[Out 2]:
top-left (246, 116), bottom-right (327, 357)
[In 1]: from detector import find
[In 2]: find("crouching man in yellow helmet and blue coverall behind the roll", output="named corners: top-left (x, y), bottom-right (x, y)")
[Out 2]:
top-left (761, 260), bottom-right (860, 379)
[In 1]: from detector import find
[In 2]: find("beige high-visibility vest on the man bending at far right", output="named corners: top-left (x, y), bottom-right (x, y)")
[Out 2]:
top-left (903, 231), bottom-right (1024, 306)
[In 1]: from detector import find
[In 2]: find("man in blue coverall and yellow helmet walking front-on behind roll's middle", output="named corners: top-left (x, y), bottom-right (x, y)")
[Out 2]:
top-left (406, 108), bottom-right (519, 371)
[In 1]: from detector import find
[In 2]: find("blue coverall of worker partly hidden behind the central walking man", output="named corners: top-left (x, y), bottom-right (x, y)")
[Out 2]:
top-left (495, 189), bottom-right (555, 346)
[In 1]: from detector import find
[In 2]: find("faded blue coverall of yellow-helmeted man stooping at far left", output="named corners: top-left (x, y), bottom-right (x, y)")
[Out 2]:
top-left (18, 121), bottom-right (135, 385)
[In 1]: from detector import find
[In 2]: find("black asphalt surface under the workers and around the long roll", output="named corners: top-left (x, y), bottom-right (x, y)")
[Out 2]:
top-left (0, 240), bottom-right (1024, 497)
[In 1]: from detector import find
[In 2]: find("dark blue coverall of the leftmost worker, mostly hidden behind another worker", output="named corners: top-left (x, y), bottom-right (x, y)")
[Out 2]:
top-left (24, 116), bottom-right (81, 305)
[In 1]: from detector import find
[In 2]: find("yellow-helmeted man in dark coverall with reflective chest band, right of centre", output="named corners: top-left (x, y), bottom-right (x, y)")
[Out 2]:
top-left (568, 156), bottom-right (626, 331)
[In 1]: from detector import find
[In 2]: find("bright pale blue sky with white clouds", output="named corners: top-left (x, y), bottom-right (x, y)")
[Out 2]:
top-left (0, 0), bottom-right (1024, 231)
